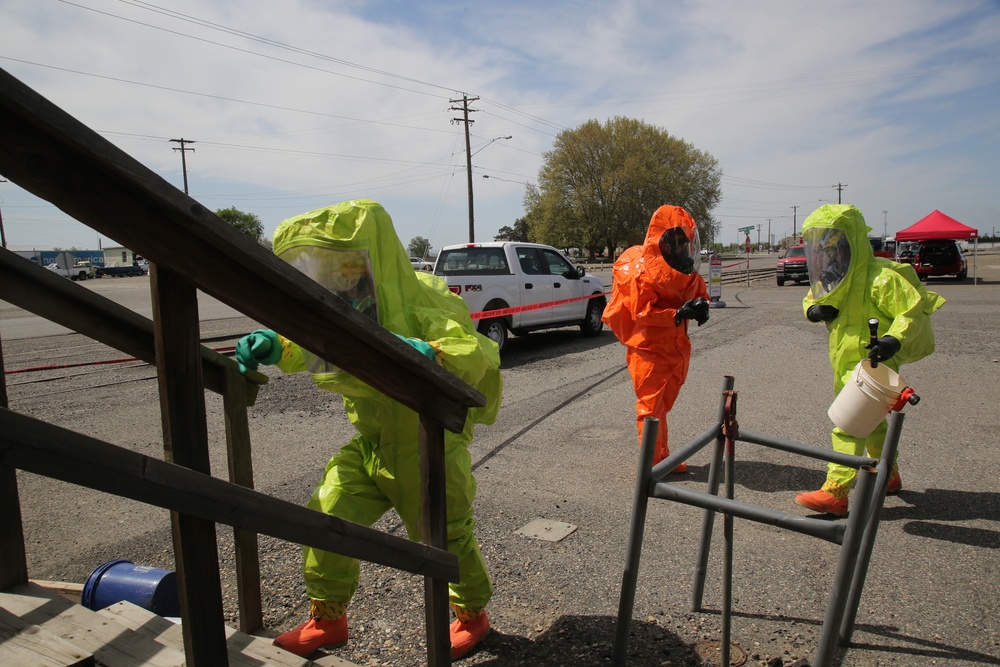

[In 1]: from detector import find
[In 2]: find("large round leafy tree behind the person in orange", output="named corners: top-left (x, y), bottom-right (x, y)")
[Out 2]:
top-left (524, 117), bottom-right (722, 257)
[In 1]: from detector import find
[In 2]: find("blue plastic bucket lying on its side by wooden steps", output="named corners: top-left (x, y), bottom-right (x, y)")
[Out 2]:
top-left (80, 560), bottom-right (181, 616)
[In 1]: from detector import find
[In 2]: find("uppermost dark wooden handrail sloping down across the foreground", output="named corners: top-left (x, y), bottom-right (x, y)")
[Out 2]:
top-left (0, 65), bottom-right (486, 432)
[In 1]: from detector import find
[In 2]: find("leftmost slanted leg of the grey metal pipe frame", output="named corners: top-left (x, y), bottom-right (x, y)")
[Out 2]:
top-left (611, 417), bottom-right (660, 667)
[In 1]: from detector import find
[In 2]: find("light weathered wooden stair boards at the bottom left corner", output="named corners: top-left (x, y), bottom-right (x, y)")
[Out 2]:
top-left (0, 582), bottom-right (356, 667)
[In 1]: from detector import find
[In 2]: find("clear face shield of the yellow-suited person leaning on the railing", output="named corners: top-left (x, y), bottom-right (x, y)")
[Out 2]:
top-left (278, 245), bottom-right (378, 374)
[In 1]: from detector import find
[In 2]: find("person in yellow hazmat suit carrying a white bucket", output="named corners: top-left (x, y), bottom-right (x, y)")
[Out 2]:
top-left (795, 204), bottom-right (944, 516)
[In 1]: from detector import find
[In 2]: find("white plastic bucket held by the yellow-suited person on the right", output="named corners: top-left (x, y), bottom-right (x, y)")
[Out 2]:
top-left (827, 359), bottom-right (906, 438)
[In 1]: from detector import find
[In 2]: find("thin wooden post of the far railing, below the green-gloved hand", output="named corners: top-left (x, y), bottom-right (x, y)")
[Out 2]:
top-left (222, 368), bottom-right (264, 634)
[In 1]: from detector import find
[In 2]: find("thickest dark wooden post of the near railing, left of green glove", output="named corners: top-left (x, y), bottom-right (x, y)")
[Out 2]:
top-left (150, 265), bottom-right (229, 667)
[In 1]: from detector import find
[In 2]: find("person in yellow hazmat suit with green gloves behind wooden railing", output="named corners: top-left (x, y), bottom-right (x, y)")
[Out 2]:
top-left (236, 200), bottom-right (503, 658)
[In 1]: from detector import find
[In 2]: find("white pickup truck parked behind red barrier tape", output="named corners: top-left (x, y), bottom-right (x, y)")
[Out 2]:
top-left (434, 241), bottom-right (606, 350)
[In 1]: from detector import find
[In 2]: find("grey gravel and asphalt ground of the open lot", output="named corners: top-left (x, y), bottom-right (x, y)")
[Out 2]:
top-left (3, 256), bottom-right (1000, 667)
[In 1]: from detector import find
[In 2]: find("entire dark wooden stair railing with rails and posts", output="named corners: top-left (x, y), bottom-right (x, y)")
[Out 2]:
top-left (0, 65), bottom-right (462, 666)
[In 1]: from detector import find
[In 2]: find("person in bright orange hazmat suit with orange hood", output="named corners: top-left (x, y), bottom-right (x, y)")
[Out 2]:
top-left (603, 206), bottom-right (709, 473)
